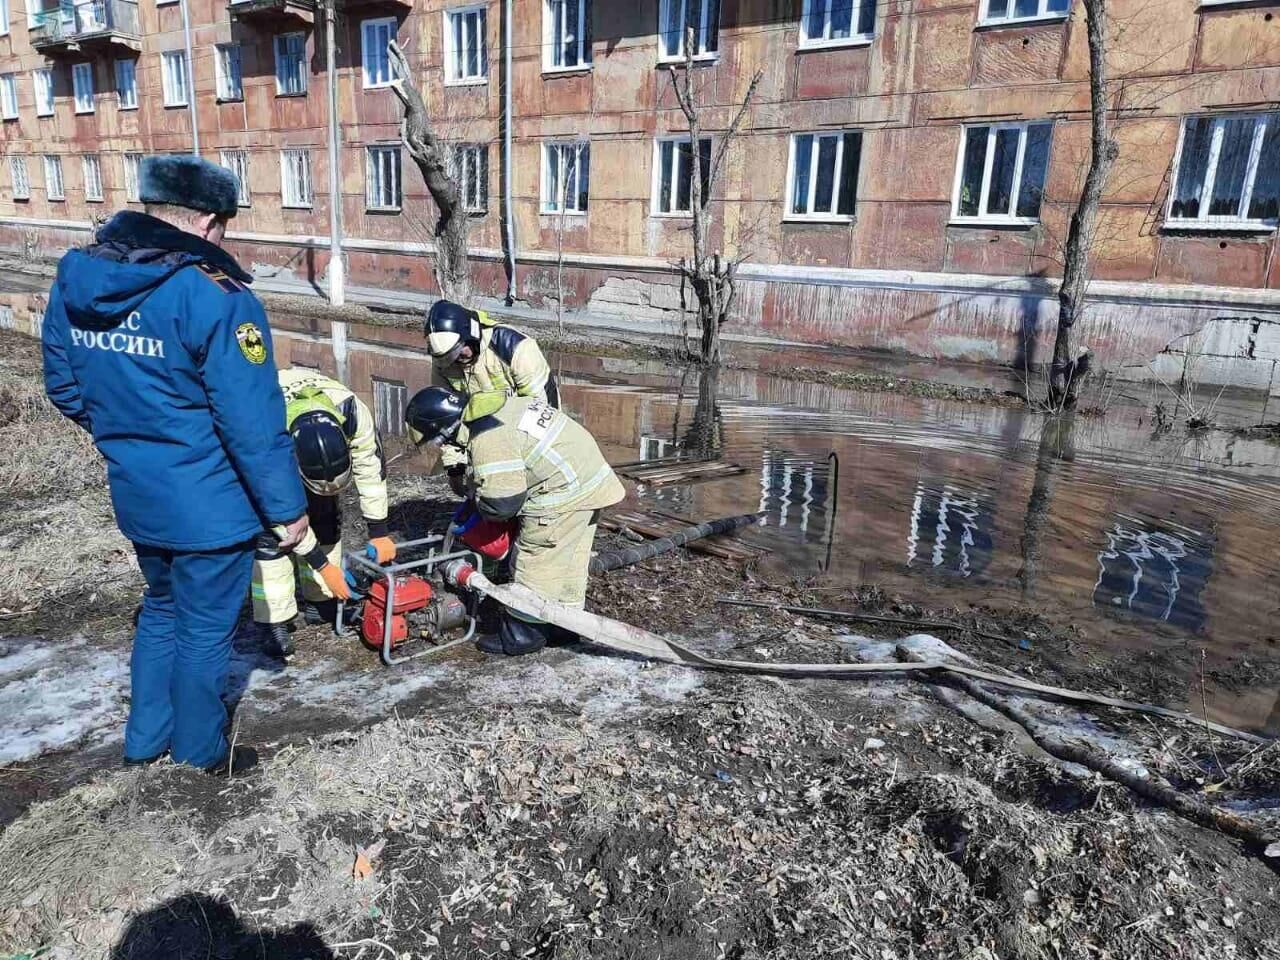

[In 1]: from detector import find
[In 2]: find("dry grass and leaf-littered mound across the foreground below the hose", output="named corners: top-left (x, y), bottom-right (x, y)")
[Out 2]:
top-left (0, 678), bottom-right (1280, 960)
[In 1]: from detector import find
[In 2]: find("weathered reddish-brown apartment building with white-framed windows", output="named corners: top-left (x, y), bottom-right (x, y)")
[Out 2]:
top-left (0, 0), bottom-right (1280, 385)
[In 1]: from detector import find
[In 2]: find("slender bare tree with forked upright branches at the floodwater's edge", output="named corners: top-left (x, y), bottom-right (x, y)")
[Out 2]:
top-left (667, 27), bottom-right (764, 364)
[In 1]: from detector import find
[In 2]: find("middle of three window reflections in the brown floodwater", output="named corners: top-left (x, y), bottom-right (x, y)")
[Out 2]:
top-left (906, 483), bottom-right (993, 577)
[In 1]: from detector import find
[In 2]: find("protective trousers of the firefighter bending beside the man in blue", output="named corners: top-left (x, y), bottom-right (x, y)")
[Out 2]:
top-left (251, 492), bottom-right (342, 623)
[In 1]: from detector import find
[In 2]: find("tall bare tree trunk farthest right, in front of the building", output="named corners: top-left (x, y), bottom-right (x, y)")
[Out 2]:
top-left (1048, 0), bottom-right (1120, 410)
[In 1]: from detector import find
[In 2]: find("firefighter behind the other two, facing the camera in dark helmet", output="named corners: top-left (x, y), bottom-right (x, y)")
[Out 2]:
top-left (422, 300), bottom-right (559, 497)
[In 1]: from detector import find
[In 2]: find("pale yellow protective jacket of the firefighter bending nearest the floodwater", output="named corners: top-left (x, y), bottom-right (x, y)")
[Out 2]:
top-left (467, 397), bottom-right (626, 520)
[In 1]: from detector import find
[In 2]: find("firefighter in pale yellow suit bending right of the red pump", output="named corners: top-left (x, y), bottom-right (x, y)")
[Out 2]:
top-left (404, 387), bottom-right (625, 657)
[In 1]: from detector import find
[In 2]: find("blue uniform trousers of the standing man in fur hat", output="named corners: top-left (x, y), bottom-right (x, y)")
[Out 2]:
top-left (124, 540), bottom-right (253, 767)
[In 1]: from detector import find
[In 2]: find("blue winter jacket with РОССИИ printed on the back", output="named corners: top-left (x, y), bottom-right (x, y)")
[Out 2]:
top-left (44, 211), bottom-right (306, 552)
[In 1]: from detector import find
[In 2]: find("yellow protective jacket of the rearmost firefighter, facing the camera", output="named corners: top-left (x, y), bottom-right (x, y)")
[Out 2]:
top-left (431, 310), bottom-right (559, 467)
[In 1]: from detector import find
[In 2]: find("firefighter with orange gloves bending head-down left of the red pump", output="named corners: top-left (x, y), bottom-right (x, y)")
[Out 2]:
top-left (253, 367), bottom-right (396, 655)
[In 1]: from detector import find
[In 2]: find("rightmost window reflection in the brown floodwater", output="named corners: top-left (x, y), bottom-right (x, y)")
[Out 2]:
top-left (1093, 515), bottom-right (1213, 630)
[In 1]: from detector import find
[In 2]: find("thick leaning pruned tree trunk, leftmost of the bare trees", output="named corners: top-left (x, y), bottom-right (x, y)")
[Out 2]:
top-left (387, 41), bottom-right (471, 302)
